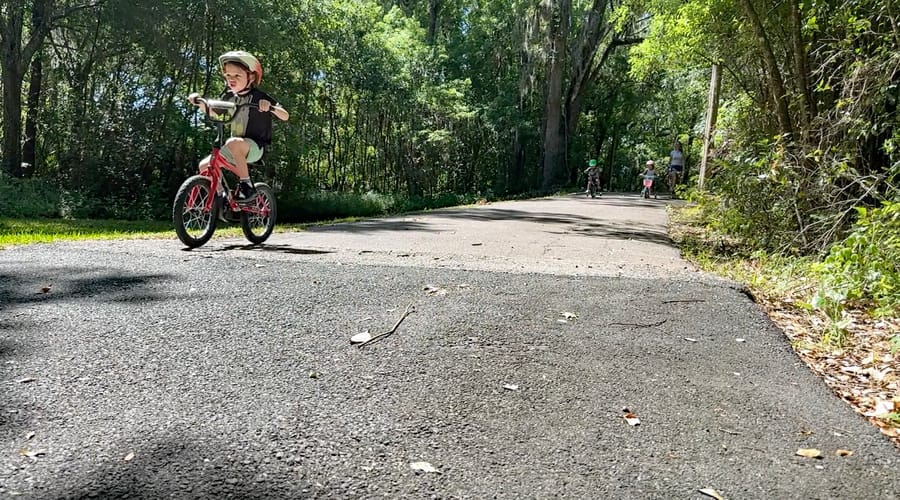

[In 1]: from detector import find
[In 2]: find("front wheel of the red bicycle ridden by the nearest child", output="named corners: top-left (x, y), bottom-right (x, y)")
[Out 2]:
top-left (172, 175), bottom-right (222, 248)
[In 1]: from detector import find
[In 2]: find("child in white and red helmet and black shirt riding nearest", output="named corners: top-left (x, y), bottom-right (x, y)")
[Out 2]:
top-left (188, 50), bottom-right (289, 204)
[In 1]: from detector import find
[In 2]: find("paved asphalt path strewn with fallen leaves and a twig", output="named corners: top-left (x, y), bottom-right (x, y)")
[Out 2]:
top-left (0, 195), bottom-right (900, 499)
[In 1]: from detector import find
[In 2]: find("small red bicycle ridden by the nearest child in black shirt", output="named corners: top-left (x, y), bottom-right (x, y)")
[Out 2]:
top-left (172, 98), bottom-right (278, 248)
